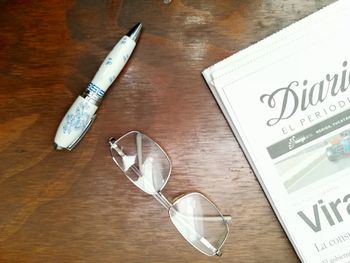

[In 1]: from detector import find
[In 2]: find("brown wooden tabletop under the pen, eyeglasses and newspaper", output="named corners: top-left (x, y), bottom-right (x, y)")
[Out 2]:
top-left (0, 0), bottom-right (334, 263)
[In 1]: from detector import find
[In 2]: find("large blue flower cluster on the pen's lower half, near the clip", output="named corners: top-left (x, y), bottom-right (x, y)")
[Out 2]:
top-left (63, 102), bottom-right (91, 134)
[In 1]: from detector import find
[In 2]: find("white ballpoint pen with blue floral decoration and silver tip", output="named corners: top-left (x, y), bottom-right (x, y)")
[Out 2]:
top-left (55, 23), bottom-right (142, 150)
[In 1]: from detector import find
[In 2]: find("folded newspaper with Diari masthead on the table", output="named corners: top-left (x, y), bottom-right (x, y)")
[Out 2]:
top-left (203, 0), bottom-right (350, 263)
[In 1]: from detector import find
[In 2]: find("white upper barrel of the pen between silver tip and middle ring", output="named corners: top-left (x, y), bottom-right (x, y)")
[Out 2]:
top-left (91, 36), bottom-right (136, 95)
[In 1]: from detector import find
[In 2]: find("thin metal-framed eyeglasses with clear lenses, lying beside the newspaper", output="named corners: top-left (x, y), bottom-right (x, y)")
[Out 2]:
top-left (109, 131), bottom-right (231, 256)
